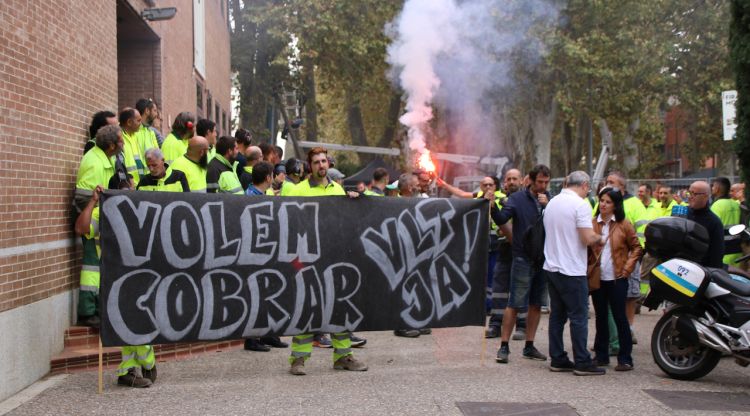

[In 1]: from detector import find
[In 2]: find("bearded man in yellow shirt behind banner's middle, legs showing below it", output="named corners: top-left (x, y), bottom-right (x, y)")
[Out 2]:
top-left (289, 147), bottom-right (367, 376)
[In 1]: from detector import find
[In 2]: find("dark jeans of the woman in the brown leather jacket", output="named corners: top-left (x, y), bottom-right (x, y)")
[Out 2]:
top-left (591, 279), bottom-right (633, 365)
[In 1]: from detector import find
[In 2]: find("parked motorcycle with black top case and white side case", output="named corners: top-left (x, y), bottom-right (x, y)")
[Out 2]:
top-left (643, 217), bottom-right (750, 380)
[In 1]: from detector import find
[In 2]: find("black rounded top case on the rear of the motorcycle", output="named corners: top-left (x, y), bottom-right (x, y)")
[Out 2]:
top-left (645, 217), bottom-right (708, 259)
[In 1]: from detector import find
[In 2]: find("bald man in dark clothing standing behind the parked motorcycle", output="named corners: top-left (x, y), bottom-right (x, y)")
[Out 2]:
top-left (687, 181), bottom-right (724, 268)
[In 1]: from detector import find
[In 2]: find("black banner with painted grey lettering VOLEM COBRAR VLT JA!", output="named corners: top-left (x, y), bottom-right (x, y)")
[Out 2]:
top-left (100, 191), bottom-right (488, 346)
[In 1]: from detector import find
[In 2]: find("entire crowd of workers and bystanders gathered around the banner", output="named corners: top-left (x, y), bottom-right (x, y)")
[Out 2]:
top-left (75, 99), bottom-right (747, 387)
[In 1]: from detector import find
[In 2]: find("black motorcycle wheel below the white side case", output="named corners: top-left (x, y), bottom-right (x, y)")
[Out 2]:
top-left (651, 307), bottom-right (721, 380)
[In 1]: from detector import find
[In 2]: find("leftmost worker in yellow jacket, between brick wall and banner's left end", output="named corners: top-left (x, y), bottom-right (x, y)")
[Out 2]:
top-left (74, 125), bottom-right (124, 328)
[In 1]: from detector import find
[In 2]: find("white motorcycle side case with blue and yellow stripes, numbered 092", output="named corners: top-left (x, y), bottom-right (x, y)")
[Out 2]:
top-left (649, 259), bottom-right (711, 306)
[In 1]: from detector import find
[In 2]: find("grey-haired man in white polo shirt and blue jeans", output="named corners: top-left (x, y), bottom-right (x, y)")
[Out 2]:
top-left (543, 171), bottom-right (605, 376)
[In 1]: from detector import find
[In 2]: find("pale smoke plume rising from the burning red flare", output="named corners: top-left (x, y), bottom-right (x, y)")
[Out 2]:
top-left (386, 0), bottom-right (558, 158)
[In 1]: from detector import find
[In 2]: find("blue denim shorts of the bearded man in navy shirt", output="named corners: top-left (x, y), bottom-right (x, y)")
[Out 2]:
top-left (508, 257), bottom-right (547, 309)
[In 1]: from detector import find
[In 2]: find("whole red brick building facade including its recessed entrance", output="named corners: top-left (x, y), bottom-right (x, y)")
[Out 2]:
top-left (0, 0), bottom-right (231, 313)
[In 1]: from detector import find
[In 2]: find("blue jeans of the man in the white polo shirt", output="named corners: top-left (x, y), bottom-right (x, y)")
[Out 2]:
top-left (546, 272), bottom-right (591, 368)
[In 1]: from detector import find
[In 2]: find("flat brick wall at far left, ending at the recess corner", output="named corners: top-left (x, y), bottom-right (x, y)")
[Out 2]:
top-left (0, 0), bottom-right (117, 312)
